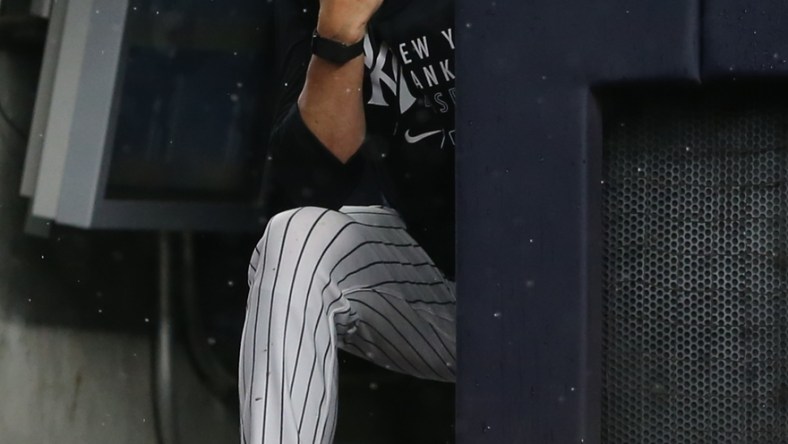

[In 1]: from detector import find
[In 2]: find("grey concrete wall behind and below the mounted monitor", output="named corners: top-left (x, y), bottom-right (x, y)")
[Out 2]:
top-left (0, 48), bottom-right (238, 444)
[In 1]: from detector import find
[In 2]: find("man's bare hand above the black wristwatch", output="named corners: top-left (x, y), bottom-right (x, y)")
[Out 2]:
top-left (317, 0), bottom-right (384, 45)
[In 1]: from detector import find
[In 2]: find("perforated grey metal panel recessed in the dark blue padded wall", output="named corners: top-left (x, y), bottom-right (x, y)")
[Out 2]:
top-left (602, 89), bottom-right (788, 444)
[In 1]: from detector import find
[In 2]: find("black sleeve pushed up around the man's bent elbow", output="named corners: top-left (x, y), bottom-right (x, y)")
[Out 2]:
top-left (264, 0), bottom-right (366, 213)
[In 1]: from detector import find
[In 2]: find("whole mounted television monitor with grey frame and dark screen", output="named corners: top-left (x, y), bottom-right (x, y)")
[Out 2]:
top-left (24, 0), bottom-right (272, 231)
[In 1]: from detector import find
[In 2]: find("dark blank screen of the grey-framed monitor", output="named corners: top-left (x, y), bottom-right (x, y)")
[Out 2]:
top-left (104, 0), bottom-right (273, 202)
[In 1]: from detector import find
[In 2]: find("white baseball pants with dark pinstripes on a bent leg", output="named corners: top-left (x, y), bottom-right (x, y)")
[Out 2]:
top-left (239, 207), bottom-right (455, 444)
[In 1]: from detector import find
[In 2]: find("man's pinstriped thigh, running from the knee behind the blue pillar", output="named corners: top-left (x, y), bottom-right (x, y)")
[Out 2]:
top-left (332, 207), bottom-right (456, 381)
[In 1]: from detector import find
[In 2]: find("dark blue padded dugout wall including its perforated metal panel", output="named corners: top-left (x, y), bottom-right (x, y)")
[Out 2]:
top-left (457, 0), bottom-right (788, 444)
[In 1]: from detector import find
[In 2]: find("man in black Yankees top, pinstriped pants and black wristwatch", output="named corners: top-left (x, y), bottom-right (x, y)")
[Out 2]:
top-left (239, 0), bottom-right (455, 444)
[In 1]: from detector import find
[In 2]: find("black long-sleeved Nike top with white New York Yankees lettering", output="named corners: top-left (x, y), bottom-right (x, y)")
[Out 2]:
top-left (266, 0), bottom-right (456, 276)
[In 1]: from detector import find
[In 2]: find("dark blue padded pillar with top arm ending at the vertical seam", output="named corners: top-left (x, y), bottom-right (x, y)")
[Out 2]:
top-left (457, 0), bottom-right (701, 444)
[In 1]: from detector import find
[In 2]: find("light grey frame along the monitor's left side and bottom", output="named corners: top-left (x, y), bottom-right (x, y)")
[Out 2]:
top-left (25, 0), bottom-right (265, 232)
